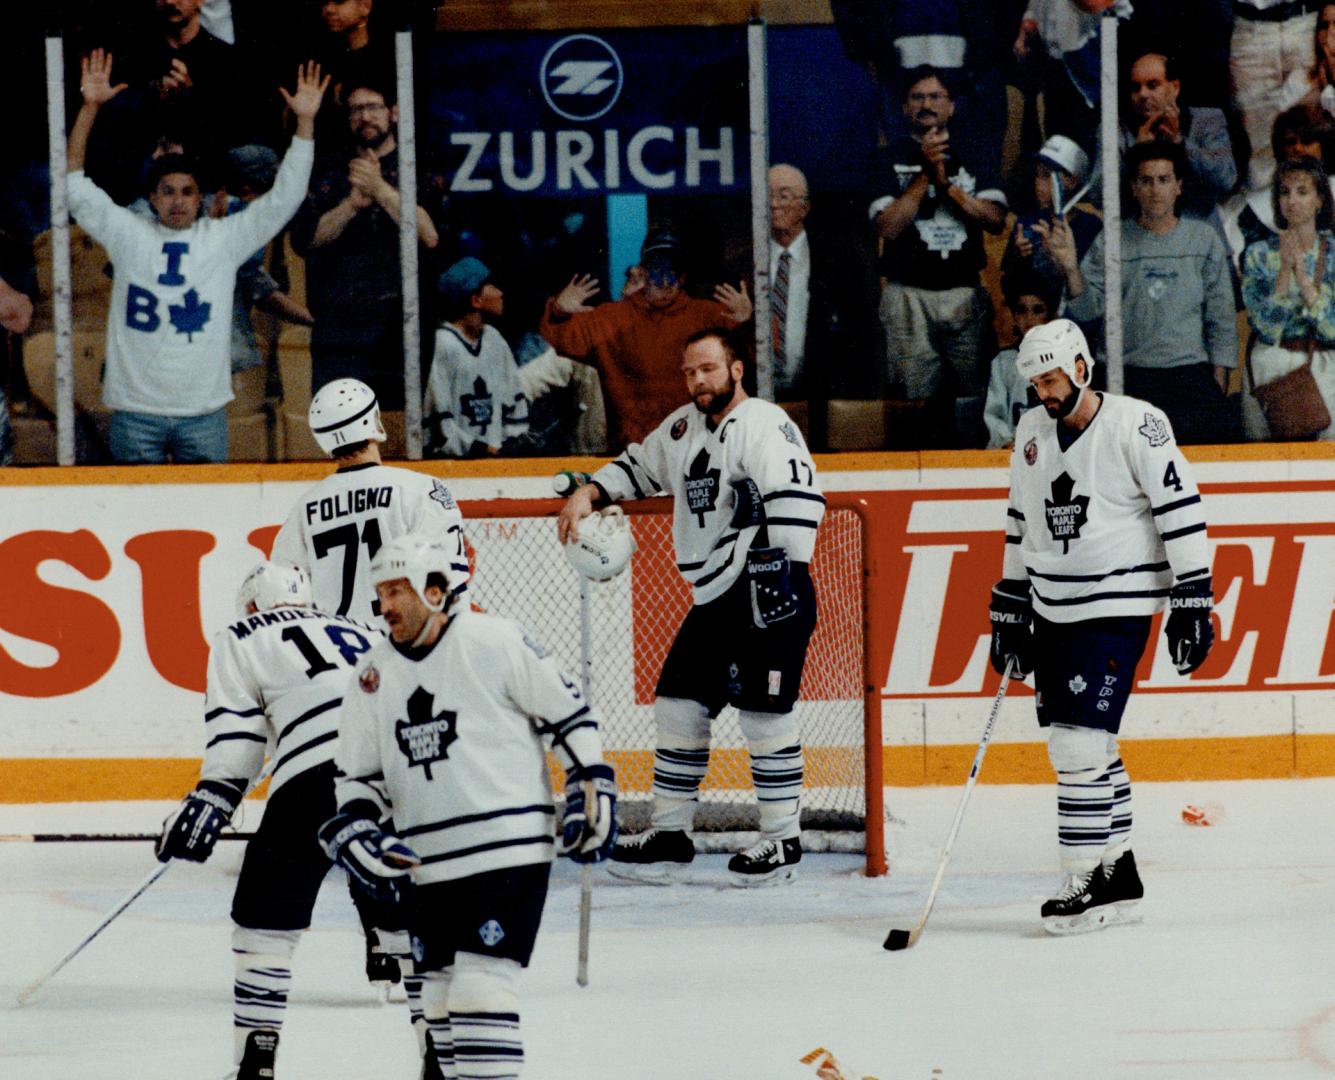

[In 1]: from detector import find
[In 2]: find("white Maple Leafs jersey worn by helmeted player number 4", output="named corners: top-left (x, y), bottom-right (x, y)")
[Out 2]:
top-left (1003, 394), bottom-right (1210, 622)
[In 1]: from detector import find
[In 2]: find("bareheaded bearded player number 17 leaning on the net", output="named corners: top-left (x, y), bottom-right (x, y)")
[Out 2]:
top-left (558, 330), bottom-right (825, 885)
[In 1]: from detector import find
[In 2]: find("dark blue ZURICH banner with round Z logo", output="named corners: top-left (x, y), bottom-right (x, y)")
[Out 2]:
top-left (426, 27), bottom-right (750, 198)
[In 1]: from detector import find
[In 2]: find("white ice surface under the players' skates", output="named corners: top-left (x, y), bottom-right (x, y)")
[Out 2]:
top-left (0, 780), bottom-right (1335, 1080)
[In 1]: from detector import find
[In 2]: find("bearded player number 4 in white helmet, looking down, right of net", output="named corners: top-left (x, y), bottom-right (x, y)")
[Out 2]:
top-left (991, 319), bottom-right (1214, 933)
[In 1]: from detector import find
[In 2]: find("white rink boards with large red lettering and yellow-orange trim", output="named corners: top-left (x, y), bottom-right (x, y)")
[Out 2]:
top-left (0, 446), bottom-right (1335, 802)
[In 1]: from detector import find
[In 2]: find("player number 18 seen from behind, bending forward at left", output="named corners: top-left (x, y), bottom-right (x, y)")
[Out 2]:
top-left (156, 562), bottom-right (383, 1080)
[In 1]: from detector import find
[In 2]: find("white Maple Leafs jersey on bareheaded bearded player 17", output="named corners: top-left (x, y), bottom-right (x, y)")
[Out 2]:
top-left (593, 398), bottom-right (825, 603)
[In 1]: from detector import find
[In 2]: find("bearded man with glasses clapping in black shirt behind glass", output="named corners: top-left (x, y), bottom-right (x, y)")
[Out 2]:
top-left (291, 80), bottom-right (439, 410)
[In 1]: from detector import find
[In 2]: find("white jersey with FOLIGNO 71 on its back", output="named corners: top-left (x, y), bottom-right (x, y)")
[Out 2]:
top-left (271, 462), bottom-right (469, 619)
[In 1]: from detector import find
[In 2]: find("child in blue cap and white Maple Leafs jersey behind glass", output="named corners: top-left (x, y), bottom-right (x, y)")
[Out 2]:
top-left (422, 255), bottom-right (574, 458)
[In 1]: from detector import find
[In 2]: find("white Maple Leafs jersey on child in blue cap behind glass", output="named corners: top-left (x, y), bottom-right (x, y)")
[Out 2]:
top-left (422, 323), bottom-right (574, 458)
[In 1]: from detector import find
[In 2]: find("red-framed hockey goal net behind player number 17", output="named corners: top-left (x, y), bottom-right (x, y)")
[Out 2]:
top-left (462, 493), bottom-right (885, 874)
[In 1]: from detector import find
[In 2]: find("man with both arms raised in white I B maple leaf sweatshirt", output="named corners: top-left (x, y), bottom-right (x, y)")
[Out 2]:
top-left (69, 49), bottom-right (327, 463)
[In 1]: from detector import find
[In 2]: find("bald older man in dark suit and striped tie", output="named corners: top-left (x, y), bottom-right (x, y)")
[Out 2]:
top-left (769, 164), bottom-right (881, 449)
